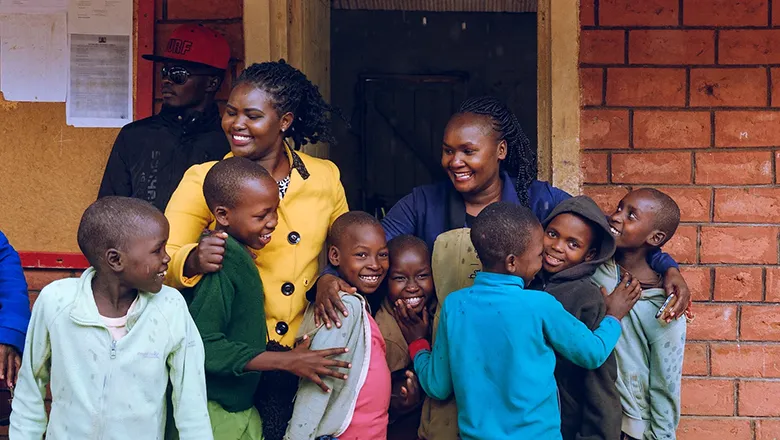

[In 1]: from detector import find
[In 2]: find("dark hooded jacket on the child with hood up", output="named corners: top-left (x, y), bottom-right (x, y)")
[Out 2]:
top-left (531, 196), bottom-right (622, 440)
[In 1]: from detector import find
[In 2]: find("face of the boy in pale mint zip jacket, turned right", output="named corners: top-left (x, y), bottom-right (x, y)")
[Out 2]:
top-left (119, 214), bottom-right (171, 293)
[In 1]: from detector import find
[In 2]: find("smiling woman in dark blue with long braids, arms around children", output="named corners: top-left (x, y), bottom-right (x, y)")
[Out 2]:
top-left (316, 97), bottom-right (690, 326)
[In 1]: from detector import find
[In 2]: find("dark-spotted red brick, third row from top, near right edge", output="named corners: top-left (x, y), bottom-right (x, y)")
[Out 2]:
top-left (691, 68), bottom-right (767, 107)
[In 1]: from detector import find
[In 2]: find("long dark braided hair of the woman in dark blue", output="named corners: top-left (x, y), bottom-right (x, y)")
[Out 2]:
top-left (458, 96), bottom-right (537, 206)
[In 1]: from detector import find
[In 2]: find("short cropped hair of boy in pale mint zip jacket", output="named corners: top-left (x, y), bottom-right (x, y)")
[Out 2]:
top-left (77, 196), bottom-right (165, 266)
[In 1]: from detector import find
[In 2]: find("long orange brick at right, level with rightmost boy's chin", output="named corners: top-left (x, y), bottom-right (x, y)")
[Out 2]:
top-left (700, 226), bottom-right (777, 264)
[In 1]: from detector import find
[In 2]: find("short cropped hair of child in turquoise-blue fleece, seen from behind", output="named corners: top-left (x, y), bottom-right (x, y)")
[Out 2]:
top-left (471, 202), bottom-right (541, 267)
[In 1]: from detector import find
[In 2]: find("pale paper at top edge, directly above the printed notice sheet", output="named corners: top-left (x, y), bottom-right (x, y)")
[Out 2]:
top-left (68, 0), bottom-right (133, 35)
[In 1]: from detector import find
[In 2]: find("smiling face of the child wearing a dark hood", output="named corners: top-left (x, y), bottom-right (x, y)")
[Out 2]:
top-left (542, 212), bottom-right (596, 273)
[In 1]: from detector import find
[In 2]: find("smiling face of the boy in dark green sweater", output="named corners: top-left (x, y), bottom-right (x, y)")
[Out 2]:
top-left (214, 176), bottom-right (279, 250)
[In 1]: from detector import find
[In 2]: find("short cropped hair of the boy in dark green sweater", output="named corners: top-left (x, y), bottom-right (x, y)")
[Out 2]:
top-left (203, 157), bottom-right (276, 211)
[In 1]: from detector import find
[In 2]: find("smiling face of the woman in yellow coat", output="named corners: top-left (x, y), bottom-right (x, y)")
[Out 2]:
top-left (222, 83), bottom-right (293, 160)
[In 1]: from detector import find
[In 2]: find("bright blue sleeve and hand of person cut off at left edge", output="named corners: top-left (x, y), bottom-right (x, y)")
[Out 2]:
top-left (0, 232), bottom-right (30, 387)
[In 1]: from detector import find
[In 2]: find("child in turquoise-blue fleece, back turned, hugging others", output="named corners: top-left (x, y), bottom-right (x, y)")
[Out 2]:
top-left (396, 202), bottom-right (639, 440)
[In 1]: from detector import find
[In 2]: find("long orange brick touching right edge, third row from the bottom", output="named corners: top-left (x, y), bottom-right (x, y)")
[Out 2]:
top-left (712, 343), bottom-right (780, 378)
